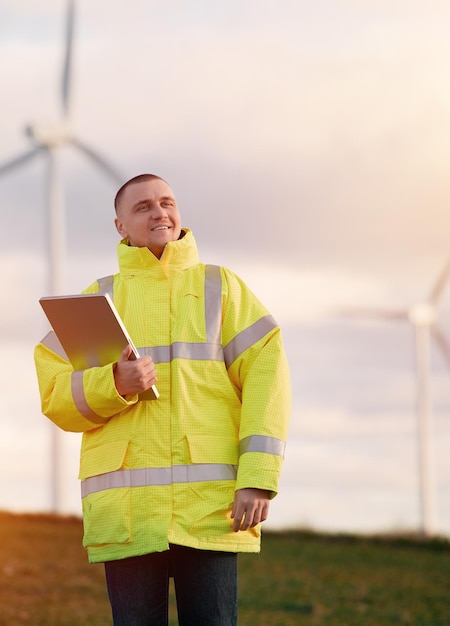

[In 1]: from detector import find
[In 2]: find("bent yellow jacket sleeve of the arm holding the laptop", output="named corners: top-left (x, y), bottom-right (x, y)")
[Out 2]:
top-left (34, 283), bottom-right (138, 432)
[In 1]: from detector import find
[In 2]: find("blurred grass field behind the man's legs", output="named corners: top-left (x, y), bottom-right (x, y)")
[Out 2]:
top-left (0, 513), bottom-right (450, 626)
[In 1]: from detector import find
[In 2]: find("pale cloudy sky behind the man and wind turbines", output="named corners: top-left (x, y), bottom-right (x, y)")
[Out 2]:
top-left (0, 0), bottom-right (450, 534)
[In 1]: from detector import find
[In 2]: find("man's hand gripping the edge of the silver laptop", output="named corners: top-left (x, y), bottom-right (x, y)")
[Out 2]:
top-left (114, 345), bottom-right (157, 396)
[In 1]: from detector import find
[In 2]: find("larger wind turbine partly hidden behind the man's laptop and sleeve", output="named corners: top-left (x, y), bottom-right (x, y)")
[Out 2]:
top-left (0, 0), bottom-right (124, 512)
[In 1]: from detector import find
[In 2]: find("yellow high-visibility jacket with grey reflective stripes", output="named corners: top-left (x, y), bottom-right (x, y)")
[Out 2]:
top-left (35, 229), bottom-right (291, 562)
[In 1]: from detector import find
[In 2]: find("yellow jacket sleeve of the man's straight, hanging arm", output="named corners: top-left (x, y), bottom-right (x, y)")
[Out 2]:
top-left (222, 270), bottom-right (291, 497)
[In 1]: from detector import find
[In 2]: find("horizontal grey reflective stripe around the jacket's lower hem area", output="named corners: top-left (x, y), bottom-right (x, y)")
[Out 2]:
top-left (81, 463), bottom-right (237, 498)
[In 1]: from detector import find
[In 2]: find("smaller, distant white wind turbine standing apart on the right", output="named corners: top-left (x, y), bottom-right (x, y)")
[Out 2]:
top-left (344, 259), bottom-right (450, 536)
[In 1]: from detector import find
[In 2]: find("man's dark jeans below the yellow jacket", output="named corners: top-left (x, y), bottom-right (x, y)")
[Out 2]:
top-left (105, 545), bottom-right (237, 626)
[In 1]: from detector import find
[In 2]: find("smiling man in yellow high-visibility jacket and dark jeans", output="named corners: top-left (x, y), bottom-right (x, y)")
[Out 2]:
top-left (35, 174), bottom-right (290, 626)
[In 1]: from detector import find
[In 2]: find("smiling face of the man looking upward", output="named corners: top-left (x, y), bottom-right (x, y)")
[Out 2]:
top-left (115, 178), bottom-right (181, 259)
